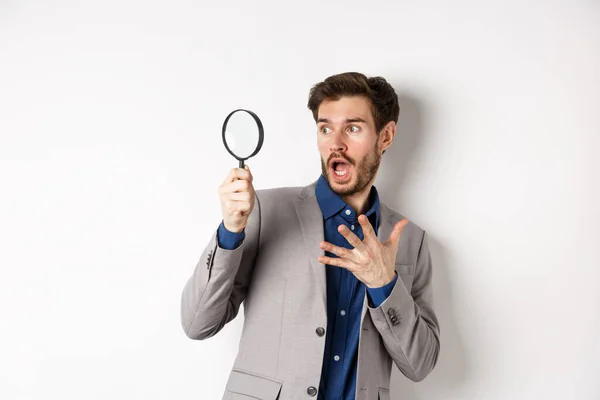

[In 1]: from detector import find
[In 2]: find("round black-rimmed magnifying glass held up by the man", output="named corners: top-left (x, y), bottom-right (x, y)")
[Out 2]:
top-left (223, 109), bottom-right (264, 168)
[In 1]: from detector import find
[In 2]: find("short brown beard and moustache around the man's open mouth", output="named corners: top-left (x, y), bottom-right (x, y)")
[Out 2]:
top-left (321, 145), bottom-right (381, 196)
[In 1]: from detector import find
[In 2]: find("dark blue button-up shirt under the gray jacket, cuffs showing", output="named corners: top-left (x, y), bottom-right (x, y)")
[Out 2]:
top-left (217, 175), bottom-right (398, 400)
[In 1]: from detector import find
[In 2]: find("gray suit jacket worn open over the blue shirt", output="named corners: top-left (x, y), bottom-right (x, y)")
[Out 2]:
top-left (181, 182), bottom-right (440, 400)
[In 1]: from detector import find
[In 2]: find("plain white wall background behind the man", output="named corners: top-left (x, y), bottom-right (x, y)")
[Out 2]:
top-left (0, 0), bottom-right (600, 400)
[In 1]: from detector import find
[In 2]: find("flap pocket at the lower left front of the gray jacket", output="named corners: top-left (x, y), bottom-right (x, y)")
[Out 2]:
top-left (226, 369), bottom-right (281, 400)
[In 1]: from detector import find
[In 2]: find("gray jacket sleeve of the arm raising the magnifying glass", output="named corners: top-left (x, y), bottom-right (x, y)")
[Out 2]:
top-left (181, 197), bottom-right (260, 340)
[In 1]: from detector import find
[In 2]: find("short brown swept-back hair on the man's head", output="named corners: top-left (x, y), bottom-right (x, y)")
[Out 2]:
top-left (308, 72), bottom-right (400, 134)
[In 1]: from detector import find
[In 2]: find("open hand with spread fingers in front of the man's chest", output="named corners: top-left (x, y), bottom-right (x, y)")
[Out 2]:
top-left (319, 215), bottom-right (408, 288)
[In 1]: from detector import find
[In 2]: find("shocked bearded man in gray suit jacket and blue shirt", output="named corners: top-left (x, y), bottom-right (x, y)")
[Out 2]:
top-left (181, 73), bottom-right (440, 400)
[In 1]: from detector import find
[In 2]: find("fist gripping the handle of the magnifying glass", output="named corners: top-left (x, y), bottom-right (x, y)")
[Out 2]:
top-left (218, 165), bottom-right (254, 233)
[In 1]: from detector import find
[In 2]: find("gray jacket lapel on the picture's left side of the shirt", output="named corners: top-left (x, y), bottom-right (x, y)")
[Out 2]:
top-left (296, 183), bottom-right (327, 310)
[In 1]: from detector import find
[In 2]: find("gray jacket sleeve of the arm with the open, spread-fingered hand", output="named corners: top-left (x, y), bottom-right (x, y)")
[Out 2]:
top-left (369, 228), bottom-right (440, 382)
